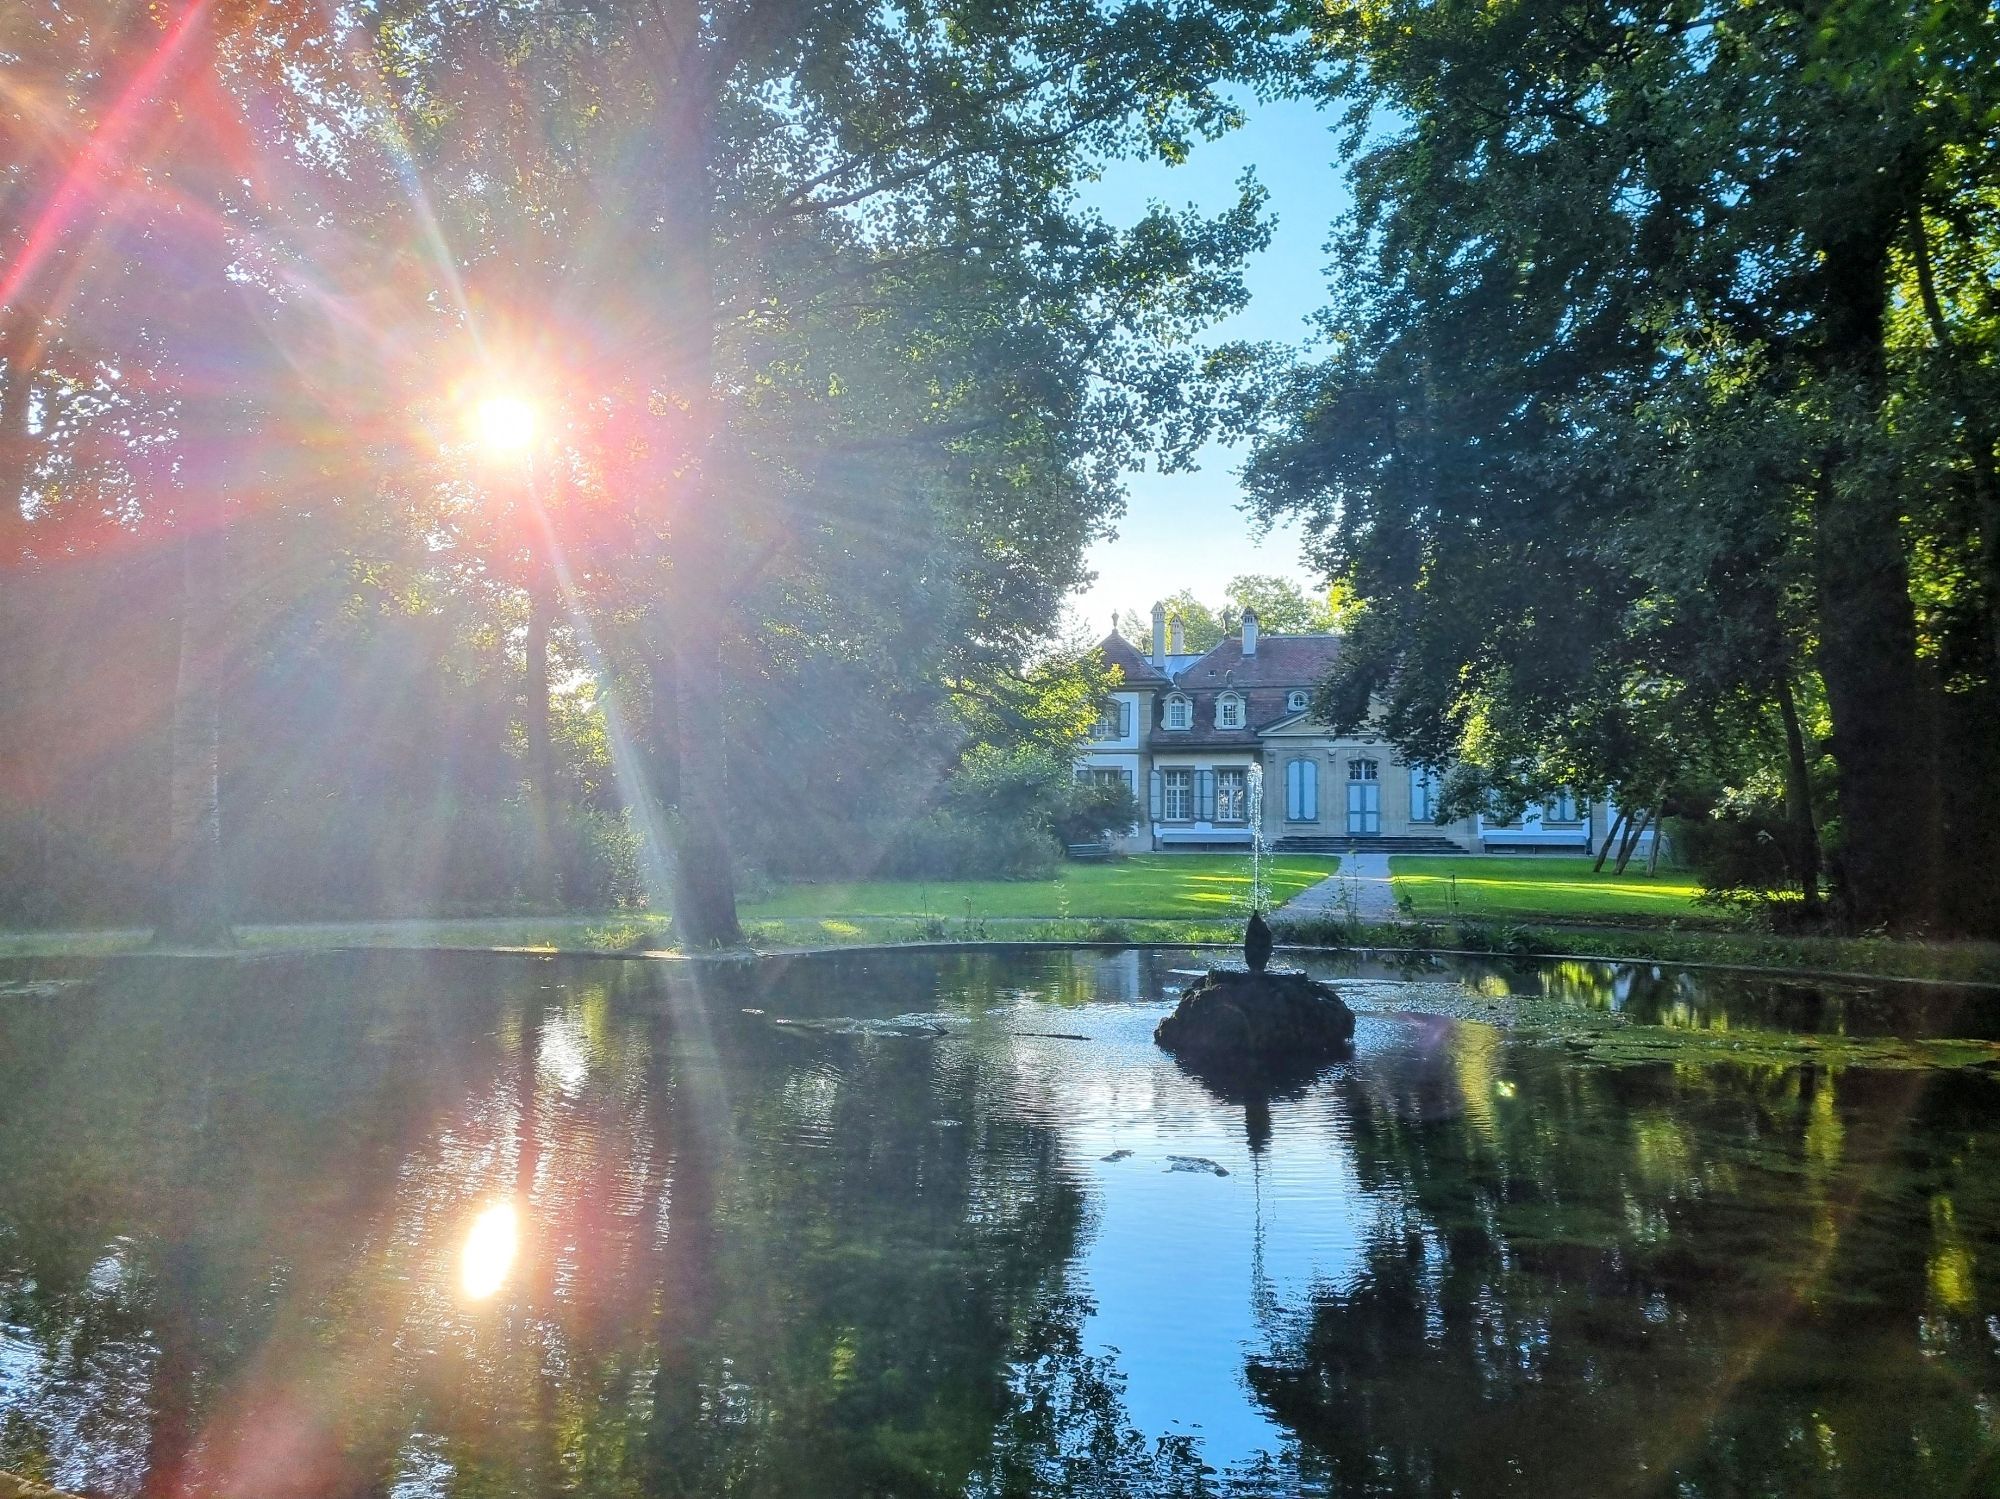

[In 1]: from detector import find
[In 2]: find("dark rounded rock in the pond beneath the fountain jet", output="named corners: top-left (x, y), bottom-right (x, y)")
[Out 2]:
top-left (1152, 967), bottom-right (1354, 1075)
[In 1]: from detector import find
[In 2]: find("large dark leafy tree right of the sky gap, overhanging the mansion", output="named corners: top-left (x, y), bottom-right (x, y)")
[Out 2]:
top-left (1252, 4), bottom-right (2000, 927)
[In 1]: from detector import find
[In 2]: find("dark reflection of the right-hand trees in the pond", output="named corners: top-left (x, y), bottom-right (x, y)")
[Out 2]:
top-left (1250, 1045), bottom-right (2000, 1495)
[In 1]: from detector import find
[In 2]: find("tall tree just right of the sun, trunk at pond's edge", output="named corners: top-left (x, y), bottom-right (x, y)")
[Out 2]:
top-left (376, 0), bottom-right (1268, 945)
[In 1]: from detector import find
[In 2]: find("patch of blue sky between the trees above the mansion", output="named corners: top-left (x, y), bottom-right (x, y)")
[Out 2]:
top-left (1074, 100), bottom-right (1348, 636)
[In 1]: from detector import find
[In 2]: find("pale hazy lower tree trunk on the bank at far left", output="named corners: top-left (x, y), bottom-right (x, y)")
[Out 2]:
top-left (154, 528), bottom-right (230, 947)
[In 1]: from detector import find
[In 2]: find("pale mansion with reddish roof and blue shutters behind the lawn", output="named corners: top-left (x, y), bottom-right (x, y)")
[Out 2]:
top-left (1076, 604), bottom-right (1608, 853)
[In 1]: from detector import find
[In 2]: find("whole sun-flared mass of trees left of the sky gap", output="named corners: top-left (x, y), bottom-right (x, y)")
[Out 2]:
top-left (0, 0), bottom-right (1278, 943)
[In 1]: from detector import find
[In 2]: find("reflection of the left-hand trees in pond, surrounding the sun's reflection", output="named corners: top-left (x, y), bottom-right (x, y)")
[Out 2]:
top-left (0, 959), bottom-right (1198, 1495)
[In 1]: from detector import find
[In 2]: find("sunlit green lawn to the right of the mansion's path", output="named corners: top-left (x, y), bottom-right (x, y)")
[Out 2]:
top-left (1388, 853), bottom-right (1714, 921)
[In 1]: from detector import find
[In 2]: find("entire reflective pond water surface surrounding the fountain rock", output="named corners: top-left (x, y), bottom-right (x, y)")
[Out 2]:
top-left (0, 951), bottom-right (2000, 1499)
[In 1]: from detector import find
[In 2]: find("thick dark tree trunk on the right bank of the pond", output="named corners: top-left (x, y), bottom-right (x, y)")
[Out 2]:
top-left (1812, 218), bottom-right (1938, 927)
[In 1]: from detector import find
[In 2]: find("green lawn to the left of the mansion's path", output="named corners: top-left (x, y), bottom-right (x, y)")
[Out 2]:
top-left (742, 853), bottom-right (1340, 921)
